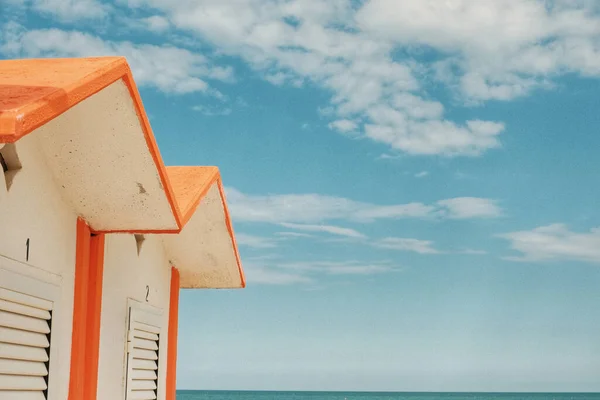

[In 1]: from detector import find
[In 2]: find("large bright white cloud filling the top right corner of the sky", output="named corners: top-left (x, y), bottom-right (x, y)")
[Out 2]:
top-left (356, 0), bottom-right (600, 100)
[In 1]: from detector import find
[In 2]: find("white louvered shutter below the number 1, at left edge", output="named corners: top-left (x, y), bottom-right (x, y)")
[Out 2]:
top-left (0, 287), bottom-right (53, 400)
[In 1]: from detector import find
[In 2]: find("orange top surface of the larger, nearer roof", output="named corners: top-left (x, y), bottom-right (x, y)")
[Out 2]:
top-left (0, 57), bottom-right (129, 143)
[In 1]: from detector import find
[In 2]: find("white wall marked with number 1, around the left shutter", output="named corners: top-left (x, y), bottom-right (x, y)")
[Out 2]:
top-left (0, 133), bottom-right (77, 399)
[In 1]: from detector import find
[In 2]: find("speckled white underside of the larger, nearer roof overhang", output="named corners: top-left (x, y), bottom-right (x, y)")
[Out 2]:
top-left (34, 80), bottom-right (178, 231)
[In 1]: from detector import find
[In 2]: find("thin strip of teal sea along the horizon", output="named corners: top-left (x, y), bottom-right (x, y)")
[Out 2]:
top-left (177, 390), bottom-right (600, 400)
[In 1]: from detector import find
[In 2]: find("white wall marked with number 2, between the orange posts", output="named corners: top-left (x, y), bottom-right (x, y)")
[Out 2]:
top-left (98, 234), bottom-right (171, 400)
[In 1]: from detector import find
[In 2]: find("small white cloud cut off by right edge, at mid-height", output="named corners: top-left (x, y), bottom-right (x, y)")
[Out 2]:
top-left (499, 224), bottom-right (600, 263)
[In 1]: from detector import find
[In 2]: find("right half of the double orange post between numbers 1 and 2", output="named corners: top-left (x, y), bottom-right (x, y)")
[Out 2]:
top-left (83, 234), bottom-right (104, 400)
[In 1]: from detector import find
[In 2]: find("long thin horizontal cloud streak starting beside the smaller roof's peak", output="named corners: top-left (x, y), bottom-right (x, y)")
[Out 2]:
top-left (227, 188), bottom-right (501, 224)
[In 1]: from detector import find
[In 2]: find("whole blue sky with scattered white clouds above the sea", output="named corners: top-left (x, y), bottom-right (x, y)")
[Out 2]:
top-left (0, 0), bottom-right (600, 391)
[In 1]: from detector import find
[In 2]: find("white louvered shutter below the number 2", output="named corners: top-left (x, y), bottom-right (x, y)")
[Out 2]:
top-left (126, 307), bottom-right (160, 400)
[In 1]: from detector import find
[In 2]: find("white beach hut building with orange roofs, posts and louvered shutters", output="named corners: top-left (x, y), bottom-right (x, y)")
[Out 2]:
top-left (0, 57), bottom-right (245, 400)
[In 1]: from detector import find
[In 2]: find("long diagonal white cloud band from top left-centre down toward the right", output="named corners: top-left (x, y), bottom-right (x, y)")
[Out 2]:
top-left (110, 0), bottom-right (504, 156)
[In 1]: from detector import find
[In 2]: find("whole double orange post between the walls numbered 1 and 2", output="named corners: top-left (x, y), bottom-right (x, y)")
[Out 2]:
top-left (69, 218), bottom-right (104, 400)
